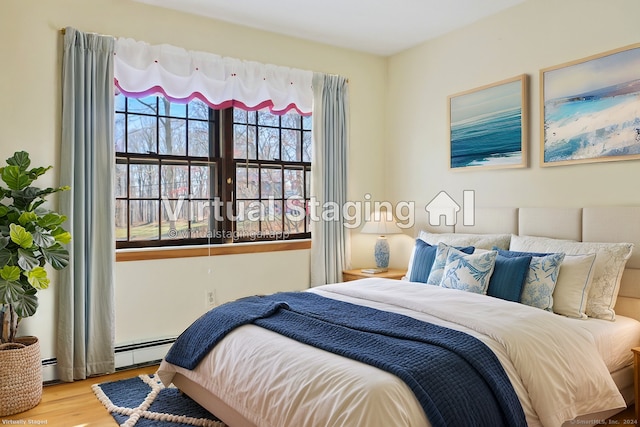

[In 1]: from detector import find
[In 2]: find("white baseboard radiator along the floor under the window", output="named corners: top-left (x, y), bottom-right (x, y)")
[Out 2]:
top-left (42, 338), bottom-right (176, 384)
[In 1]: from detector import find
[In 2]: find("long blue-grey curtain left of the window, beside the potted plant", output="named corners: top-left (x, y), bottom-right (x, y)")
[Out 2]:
top-left (56, 28), bottom-right (115, 381)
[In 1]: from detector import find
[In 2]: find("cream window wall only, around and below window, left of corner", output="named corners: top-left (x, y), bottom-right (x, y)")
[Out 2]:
top-left (0, 0), bottom-right (386, 364)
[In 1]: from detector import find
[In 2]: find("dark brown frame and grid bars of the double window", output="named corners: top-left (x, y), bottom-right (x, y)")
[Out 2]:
top-left (114, 95), bottom-right (311, 249)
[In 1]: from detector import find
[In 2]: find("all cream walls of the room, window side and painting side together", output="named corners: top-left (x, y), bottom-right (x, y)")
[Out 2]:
top-left (7, 0), bottom-right (640, 372)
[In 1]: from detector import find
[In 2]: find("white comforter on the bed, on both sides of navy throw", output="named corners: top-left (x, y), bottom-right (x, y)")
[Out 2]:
top-left (159, 279), bottom-right (625, 427)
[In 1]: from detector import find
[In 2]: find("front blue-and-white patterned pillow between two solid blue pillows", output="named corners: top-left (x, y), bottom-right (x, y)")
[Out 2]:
top-left (440, 248), bottom-right (498, 295)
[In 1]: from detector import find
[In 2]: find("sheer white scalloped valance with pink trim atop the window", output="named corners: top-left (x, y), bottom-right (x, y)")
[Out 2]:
top-left (114, 38), bottom-right (313, 115)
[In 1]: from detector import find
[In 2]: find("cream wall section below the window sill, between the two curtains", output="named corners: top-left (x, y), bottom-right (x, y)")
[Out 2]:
top-left (116, 250), bottom-right (309, 344)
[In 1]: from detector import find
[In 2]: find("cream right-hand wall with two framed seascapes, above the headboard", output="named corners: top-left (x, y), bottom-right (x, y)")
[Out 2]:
top-left (385, 0), bottom-right (640, 265)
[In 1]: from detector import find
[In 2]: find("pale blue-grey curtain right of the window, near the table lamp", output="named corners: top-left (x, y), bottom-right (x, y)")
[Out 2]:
top-left (311, 73), bottom-right (350, 286)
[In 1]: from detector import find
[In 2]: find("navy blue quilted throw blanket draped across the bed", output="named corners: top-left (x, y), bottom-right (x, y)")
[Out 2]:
top-left (165, 292), bottom-right (526, 427)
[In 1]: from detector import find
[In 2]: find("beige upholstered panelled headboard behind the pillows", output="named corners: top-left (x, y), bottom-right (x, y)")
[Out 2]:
top-left (454, 206), bottom-right (640, 320)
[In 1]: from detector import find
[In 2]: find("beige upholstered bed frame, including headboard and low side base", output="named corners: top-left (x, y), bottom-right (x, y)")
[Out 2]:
top-left (174, 207), bottom-right (640, 427)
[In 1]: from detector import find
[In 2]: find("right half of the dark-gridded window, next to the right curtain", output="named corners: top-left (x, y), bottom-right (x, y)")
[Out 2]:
top-left (233, 109), bottom-right (311, 240)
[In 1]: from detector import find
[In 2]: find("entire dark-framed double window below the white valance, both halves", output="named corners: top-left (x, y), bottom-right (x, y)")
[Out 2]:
top-left (115, 95), bottom-right (311, 248)
